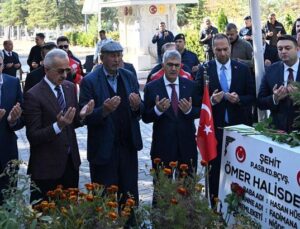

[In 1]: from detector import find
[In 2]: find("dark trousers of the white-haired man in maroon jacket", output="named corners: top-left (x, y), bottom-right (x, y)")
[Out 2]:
top-left (30, 154), bottom-right (79, 202)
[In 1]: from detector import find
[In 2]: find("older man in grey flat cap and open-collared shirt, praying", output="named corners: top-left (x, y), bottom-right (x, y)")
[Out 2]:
top-left (79, 41), bottom-right (143, 211)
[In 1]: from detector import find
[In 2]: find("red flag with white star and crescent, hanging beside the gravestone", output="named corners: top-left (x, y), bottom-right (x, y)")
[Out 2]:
top-left (196, 84), bottom-right (217, 162)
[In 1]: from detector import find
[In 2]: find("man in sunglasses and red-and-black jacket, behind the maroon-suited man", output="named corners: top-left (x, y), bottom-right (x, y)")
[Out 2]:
top-left (56, 36), bottom-right (83, 85)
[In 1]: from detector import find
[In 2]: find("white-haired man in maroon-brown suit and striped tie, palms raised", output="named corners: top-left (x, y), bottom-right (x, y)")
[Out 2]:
top-left (24, 49), bottom-right (94, 200)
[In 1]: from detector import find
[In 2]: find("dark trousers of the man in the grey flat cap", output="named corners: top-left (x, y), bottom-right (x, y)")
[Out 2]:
top-left (90, 145), bottom-right (139, 204)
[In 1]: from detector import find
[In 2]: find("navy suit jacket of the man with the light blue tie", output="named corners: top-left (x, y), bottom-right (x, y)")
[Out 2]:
top-left (196, 60), bottom-right (255, 130)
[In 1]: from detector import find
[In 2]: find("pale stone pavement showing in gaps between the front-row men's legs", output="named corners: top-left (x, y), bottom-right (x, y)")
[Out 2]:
top-left (17, 121), bottom-right (153, 203)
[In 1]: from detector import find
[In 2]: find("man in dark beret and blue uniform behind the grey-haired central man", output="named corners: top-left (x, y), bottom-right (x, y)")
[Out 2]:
top-left (174, 33), bottom-right (200, 75)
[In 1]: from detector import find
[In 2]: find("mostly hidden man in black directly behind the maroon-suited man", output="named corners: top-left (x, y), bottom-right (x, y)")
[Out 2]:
top-left (23, 42), bottom-right (57, 94)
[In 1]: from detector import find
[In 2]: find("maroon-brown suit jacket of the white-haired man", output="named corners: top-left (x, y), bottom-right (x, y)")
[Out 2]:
top-left (23, 80), bottom-right (80, 179)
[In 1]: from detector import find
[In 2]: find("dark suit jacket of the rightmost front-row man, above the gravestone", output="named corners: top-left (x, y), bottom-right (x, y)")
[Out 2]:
top-left (257, 61), bottom-right (300, 131)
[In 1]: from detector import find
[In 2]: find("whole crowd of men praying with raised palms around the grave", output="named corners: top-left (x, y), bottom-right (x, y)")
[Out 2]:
top-left (0, 14), bottom-right (300, 225)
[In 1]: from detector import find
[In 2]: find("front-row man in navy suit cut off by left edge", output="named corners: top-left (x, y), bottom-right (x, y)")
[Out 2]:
top-left (0, 57), bottom-right (24, 205)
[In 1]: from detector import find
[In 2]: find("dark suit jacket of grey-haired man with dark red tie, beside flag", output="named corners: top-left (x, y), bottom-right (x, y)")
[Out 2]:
top-left (143, 77), bottom-right (201, 165)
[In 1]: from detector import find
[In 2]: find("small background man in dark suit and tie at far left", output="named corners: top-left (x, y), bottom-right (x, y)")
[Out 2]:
top-left (2, 40), bottom-right (21, 76)
